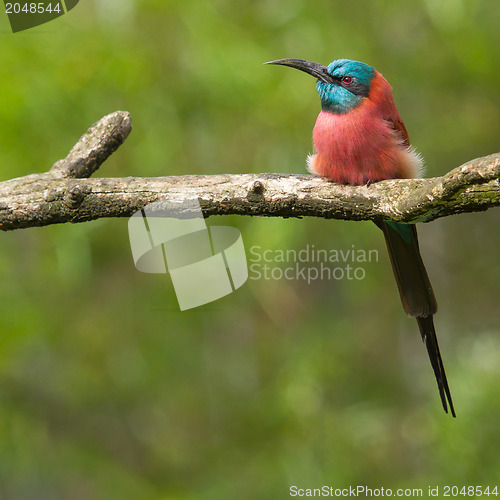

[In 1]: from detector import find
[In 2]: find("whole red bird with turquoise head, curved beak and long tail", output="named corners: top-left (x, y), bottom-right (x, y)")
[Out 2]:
top-left (264, 59), bottom-right (456, 417)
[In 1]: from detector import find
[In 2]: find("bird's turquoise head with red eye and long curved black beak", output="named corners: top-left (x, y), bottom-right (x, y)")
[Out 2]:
top-left (265, 59), bottom-right (375, 113)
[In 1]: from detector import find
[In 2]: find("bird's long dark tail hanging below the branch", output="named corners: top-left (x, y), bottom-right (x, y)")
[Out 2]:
top-left (376, 222), bottom-right (456, 417)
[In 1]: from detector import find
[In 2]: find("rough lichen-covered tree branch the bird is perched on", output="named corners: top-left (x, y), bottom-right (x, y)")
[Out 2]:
top-left (0, 111), bottom-right (500, 230)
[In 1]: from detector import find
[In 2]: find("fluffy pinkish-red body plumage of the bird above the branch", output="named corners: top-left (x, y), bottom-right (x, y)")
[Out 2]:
top-left (308, 71), bottom-right (422, 184)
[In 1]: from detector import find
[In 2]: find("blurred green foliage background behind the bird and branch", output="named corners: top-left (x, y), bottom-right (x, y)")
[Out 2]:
top-left (0, 0), bottom-right (500, 500)
